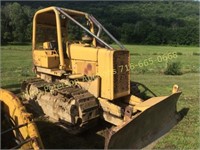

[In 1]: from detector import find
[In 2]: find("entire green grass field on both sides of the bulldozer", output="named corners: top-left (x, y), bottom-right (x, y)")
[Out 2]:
top-left (1, 45), bottom-right (200, 149)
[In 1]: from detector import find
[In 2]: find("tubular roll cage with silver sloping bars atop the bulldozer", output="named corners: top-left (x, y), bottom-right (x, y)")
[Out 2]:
top-left (32, 7), bottom-right (126, 70)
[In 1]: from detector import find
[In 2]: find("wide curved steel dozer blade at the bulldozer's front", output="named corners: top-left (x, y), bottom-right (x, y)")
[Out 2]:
top-left (105, 92), bottom-right (181, 149)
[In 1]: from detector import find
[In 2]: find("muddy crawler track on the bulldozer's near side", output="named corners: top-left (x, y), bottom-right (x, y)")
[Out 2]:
top-left (21, 78), bottom-right (99, 132)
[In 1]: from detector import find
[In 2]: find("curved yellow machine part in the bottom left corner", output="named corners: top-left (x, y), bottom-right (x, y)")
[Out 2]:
top-left (0, 89), bottom-right (44, 150)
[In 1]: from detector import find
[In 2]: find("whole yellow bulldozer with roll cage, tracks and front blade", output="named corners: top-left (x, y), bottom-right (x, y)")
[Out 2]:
top-left (1, 7), bottom-right (181, 149)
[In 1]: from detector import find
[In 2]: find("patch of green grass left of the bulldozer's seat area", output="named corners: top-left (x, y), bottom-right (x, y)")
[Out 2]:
top-left (1, 45), bottom-right (33, 90)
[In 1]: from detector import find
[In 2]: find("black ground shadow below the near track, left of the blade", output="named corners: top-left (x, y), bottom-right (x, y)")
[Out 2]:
top-left (36, 120), bottom-right (108, 149)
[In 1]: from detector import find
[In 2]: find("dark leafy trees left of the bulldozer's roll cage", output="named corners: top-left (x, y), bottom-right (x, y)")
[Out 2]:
top-left (1, 2), bottom-right (33, 42)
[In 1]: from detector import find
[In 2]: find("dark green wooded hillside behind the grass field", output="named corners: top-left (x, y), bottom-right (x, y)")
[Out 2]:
top-left (1, 1), bottom-right (199, 45)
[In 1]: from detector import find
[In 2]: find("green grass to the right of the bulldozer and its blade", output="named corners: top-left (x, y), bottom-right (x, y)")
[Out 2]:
top-left (126, 45), bottom-right (200, 149)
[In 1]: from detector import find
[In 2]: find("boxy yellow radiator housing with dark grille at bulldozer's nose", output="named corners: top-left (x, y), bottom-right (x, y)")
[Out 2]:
top-left (98, 49), bottom-right (130, 100)
